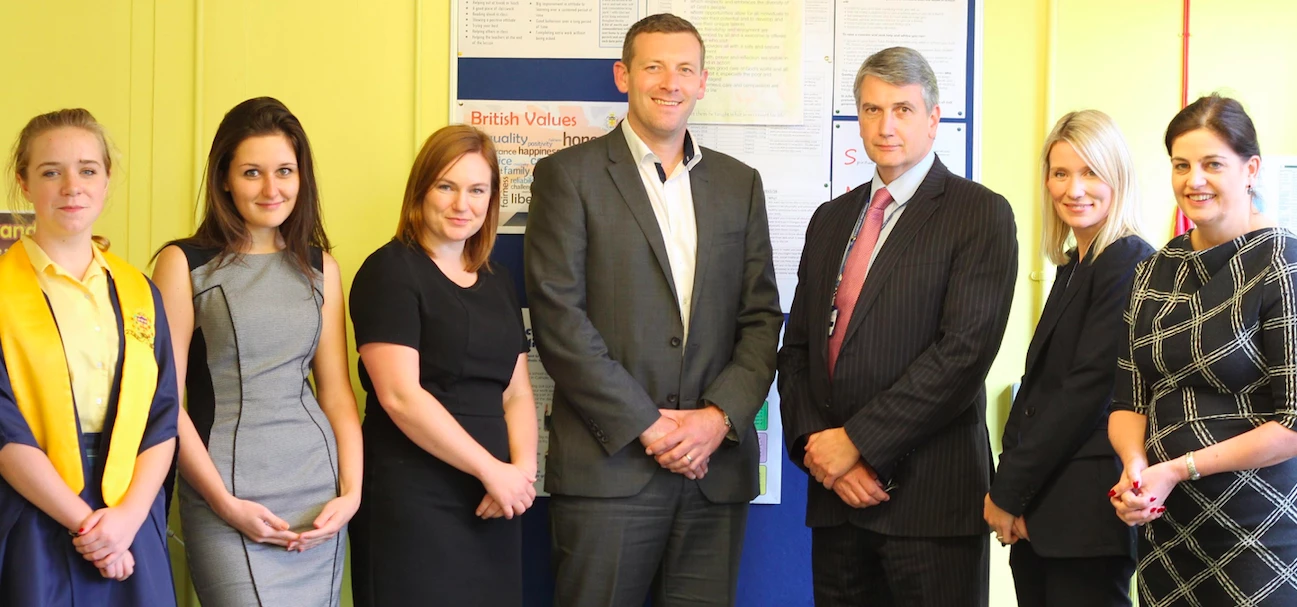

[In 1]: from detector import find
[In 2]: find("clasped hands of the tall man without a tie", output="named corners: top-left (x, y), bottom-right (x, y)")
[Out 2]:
top-left (639, 405), bottom-right (729, 480)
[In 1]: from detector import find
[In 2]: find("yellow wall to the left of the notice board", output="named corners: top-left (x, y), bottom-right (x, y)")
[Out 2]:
top-left (0, 0), bottom-right (450, 604)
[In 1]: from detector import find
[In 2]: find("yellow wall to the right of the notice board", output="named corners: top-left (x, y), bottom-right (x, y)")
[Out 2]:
top-left (981, 0), bottom-right (1297, 607)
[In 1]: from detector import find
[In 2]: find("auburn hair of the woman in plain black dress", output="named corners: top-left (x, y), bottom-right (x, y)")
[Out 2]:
top-left (396, 125), bottom-right (499, 272)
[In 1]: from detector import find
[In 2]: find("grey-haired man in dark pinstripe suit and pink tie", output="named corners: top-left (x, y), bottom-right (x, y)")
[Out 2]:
top-left (778, 48), bottom-right (1018, 607)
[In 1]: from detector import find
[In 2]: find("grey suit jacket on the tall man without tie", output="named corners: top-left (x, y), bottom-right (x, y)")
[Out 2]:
top-left (524, 128), bottom-right (783, 502)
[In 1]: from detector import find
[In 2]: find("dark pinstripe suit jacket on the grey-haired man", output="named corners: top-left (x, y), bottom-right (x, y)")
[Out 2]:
top-left (778, 160), bottom-right (1018, 537)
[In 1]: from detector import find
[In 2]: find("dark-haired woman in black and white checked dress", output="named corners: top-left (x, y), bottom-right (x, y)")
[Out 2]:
top-left (1108, 95), bottom-right (1297, 607)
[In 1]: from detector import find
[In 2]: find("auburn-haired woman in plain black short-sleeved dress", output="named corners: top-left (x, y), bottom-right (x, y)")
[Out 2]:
top-left (351, 126), bottom-right (537, 607)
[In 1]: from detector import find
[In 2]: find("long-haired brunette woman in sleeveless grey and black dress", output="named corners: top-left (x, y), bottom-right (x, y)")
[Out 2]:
top-left (153, 97), bottom-right (362, 607)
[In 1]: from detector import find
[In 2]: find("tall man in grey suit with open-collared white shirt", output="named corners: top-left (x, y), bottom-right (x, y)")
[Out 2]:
top-left (525, 14), bottom-right (783, 607)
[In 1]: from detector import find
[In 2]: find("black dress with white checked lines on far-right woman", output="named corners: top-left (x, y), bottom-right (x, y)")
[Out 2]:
top-left (1113, 228), bottom-right (1297, 607)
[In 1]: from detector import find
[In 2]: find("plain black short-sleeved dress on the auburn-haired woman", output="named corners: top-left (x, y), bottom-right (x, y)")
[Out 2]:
top-left (350, 241), bottom-right (529, 607)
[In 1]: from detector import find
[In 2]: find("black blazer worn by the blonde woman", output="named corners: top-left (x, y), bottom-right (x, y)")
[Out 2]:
top-left (991, 236), bottom-right (1153, 558)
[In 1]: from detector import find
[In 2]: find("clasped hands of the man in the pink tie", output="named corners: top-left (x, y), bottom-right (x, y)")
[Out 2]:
top-left (802, 428), bottom-right (891, 508)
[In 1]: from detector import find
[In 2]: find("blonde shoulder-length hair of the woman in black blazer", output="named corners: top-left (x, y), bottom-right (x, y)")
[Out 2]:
top-left (1040, 110), bottom-right (1141, 266)
